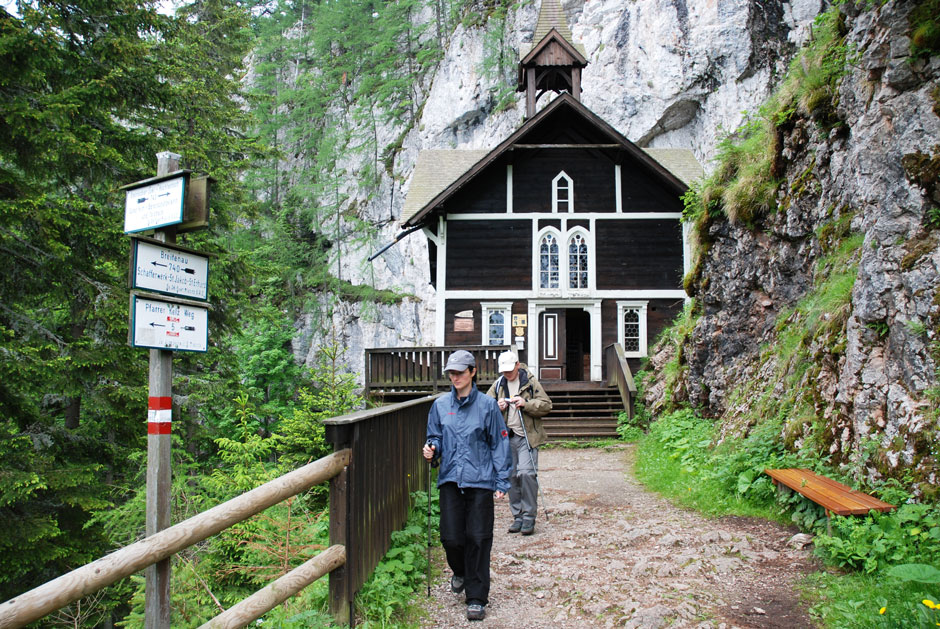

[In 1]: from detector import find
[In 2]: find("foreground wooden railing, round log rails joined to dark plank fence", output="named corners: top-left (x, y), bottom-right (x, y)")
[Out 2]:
top-left (0, 397), bottom-right (433, 629)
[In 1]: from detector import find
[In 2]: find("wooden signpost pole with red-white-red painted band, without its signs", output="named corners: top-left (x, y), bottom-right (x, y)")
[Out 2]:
top-left (144, 151), bottom-right (180, 629)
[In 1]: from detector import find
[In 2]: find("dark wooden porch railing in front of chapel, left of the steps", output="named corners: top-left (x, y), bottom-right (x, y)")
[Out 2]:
top-left (364, 345), bottom-right (510, 399)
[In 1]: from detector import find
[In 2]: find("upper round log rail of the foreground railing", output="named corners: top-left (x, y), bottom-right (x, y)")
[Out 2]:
top-left (0, 449), bottom-right (352, 629)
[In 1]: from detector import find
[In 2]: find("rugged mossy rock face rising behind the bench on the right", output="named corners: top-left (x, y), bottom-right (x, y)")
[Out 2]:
top-left (649, 2), bottom-right (940, 490)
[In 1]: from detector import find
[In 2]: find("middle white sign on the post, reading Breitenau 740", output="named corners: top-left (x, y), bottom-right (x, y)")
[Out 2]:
top-left (131, 238), bottom-right (209, 300)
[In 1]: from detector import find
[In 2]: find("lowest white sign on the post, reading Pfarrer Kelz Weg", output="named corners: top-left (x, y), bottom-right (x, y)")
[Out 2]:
top-left (131, 295), bottom-right (209, 352)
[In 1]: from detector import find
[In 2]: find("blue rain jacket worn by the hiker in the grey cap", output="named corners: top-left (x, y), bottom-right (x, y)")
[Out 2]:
top-left (427, 384), bottom-right (512, 492)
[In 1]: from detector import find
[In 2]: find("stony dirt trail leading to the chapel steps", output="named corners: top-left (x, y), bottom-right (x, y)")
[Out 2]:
top-left (422, 445), bottom-right (816, 629)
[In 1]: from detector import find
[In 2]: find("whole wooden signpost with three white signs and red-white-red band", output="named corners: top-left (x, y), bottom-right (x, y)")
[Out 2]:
top-left (124, 152), bottom-right (211, 629)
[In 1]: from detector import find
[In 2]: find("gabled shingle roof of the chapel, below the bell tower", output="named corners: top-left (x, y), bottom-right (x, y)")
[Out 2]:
top-left (401, 94), bottom-right (701, 228)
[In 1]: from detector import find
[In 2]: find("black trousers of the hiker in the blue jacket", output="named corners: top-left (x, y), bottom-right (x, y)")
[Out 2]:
top-left (440, 483), bottom-right (493, 605)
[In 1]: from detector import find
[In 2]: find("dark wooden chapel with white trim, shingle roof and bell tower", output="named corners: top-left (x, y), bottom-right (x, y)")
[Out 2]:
top-left (394, 0), bottom-right (701, 382)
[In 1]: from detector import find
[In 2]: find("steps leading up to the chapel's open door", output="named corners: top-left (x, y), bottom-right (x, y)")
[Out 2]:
top-left (542, 382), bottom-right (623, 441)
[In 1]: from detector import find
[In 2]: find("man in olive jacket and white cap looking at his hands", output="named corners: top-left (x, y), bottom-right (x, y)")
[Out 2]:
top-left (486, 352), bottom-right (552, 535)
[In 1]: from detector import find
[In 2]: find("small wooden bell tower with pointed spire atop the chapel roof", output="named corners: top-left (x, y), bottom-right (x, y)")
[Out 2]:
top-left (516, 0), bottom-right (587, 118)
